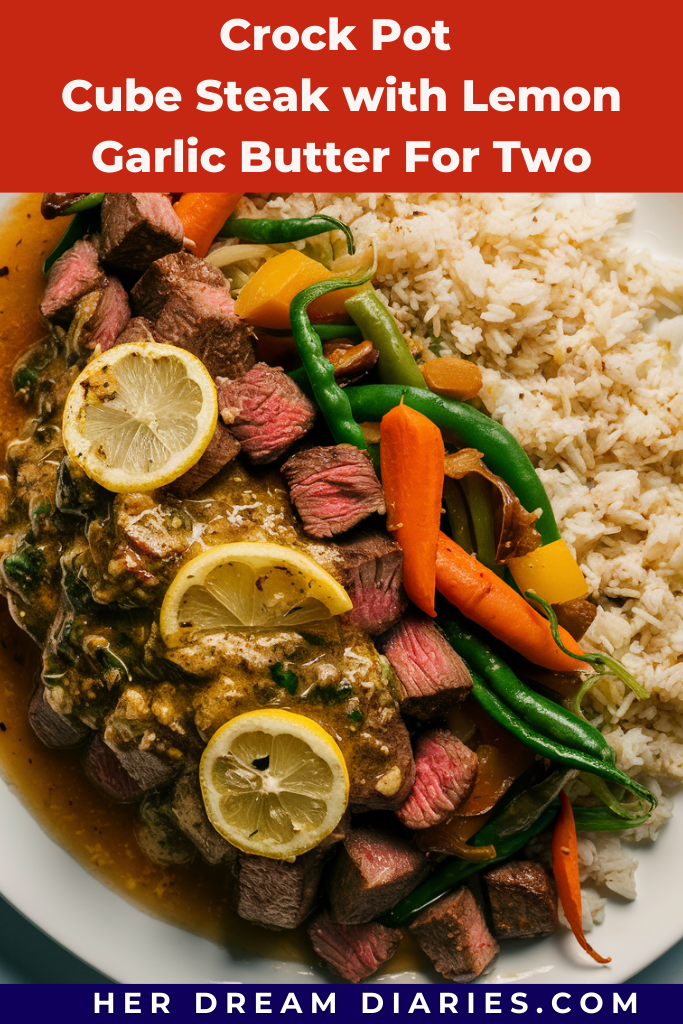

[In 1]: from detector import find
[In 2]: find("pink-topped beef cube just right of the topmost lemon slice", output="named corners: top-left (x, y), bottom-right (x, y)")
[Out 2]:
top-left (216, 362), bottom-right (315, 463)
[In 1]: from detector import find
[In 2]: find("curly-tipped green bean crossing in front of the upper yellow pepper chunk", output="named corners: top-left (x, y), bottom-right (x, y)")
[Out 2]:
top-left (290, 260), bottom-right (377, 449)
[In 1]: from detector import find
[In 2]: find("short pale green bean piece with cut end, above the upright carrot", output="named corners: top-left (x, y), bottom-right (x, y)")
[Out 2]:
top-left (344, 288), bottom-right (427, 389)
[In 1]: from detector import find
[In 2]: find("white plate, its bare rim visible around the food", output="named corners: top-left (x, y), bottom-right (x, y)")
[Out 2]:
top-left (0, 194), bottom-right (683, 985)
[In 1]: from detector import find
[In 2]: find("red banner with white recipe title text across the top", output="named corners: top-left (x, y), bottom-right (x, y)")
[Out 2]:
top-left (0, 0), bottom-right (683, 191)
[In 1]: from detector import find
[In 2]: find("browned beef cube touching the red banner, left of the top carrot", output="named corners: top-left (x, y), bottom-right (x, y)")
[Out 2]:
top-left (99, 193), bottom-right (183, 273)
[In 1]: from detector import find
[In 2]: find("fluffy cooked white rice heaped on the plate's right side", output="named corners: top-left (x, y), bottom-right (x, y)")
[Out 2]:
top-left (239, 193), bottom-right (683, 918)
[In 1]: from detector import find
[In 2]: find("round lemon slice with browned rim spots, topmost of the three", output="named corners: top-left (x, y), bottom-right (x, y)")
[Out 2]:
top-left (62, 341), bottom-right (218, 492)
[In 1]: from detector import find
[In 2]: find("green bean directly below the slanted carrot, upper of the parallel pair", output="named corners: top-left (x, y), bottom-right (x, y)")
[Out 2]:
top-left (438, 608), bottom-right (614, 764)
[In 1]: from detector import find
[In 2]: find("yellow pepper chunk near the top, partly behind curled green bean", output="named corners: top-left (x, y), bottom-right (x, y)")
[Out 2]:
top-left (234, 249), bottom-right (357, 330)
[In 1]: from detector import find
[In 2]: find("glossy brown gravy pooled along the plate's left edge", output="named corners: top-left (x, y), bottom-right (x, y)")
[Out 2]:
top-left (0, 194), bottom-right (426, 980)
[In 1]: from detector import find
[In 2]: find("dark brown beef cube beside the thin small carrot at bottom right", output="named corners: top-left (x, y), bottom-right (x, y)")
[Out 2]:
top-left (483, 860), bottom-right (558, 939)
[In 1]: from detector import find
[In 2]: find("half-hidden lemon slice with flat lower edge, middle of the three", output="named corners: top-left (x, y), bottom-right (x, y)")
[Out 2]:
top-left (160, 541), bottom-right (352, 647)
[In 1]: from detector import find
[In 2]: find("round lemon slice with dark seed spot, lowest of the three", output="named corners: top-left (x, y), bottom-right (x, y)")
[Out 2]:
top-left (200, 709), bottom-right (348, 860)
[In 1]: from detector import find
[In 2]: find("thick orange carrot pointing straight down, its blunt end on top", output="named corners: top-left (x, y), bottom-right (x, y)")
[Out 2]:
top-left (380, 402), bottom-right (444, 616)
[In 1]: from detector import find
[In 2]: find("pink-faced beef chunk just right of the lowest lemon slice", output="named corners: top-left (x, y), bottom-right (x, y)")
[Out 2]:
top-left (396, 729), bottom-right (477, 828)
